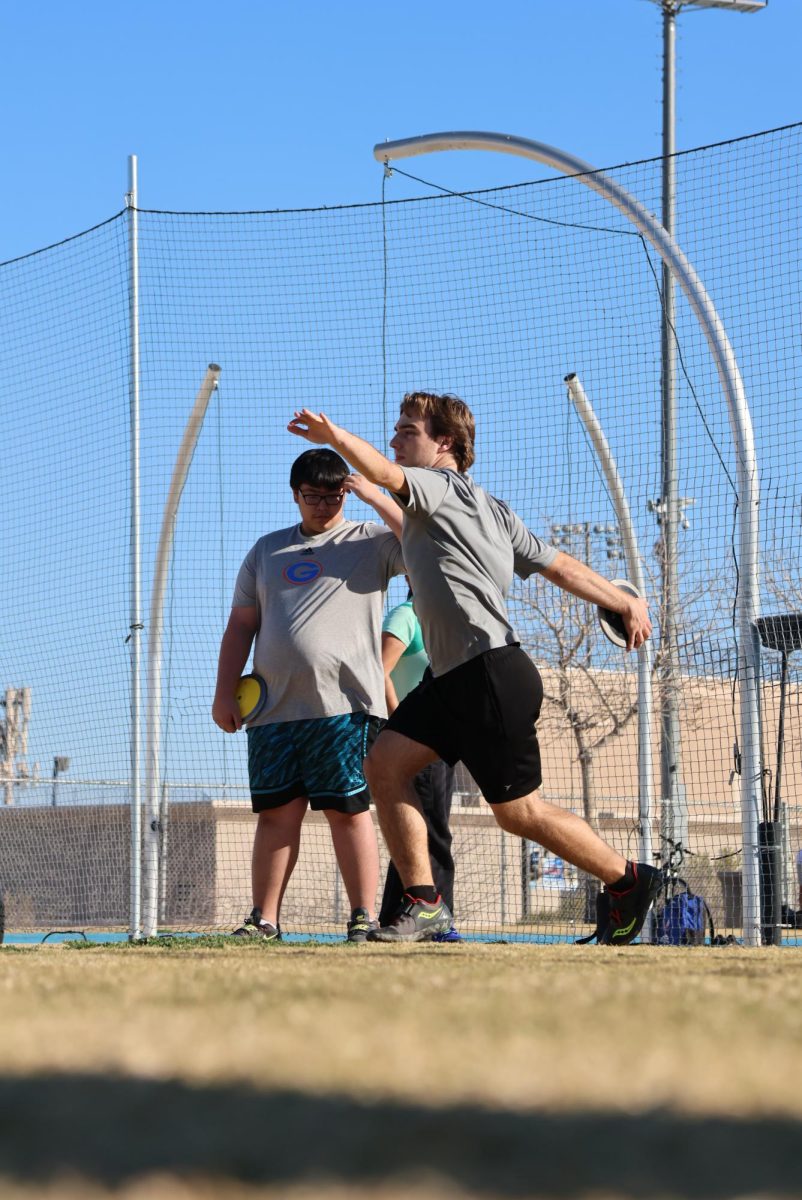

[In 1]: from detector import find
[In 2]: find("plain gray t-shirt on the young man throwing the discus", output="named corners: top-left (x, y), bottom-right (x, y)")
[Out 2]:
top-left (396, 467), bottom-right (557, 676)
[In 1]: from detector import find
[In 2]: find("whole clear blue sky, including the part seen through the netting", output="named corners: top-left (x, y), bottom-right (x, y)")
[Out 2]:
top-left (0, 0), bottom-right (802, 786)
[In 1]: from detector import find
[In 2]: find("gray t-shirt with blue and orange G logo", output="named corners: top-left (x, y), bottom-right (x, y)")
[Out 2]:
top-left (233, 521), bottom-right (403, 725)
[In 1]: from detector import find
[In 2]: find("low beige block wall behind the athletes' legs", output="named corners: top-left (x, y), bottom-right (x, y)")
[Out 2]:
top-left (0, 802), bottom-right (802, 934)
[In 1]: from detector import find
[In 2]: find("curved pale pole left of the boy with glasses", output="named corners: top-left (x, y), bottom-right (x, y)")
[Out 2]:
top-left (142, 362), bottom-right (220, 937)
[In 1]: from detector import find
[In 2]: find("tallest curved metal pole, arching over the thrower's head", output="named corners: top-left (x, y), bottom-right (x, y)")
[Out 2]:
top-left (373, 131), bottom-right (761, 946)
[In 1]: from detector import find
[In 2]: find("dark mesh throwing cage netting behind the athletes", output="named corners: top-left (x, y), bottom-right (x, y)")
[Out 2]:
top-left (0, 126), bottom-right (802, 941)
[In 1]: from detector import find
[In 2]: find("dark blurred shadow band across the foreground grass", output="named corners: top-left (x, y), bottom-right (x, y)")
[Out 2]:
top-left (0, 1074), bottom-right (802, 1200)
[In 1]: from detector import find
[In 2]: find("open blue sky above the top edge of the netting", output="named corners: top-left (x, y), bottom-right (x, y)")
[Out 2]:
top-left (0, 0), bottom-right (802, 259)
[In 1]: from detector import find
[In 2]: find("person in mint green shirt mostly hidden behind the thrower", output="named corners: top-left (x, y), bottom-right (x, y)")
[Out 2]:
top-left (378, 592), bottom-right (460, 942)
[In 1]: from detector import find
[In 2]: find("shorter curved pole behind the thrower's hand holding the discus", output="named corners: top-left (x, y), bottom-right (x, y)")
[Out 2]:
top-left (564, 374), bottom-right (653, 888)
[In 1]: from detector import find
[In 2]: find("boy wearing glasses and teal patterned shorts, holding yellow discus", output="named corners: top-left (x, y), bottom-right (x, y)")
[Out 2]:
top-left (211, 450), bottom-right (403, 942)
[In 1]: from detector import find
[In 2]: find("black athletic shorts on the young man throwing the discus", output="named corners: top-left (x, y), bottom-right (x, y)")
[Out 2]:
top-left (384, 644), bottom-right (543, 804)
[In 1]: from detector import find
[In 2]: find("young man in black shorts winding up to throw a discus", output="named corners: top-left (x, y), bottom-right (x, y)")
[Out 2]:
top-left (288, 392), bottom-right (660, 946)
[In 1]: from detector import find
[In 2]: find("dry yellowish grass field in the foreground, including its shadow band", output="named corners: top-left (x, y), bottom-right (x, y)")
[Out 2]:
top-left (0, 938), bottom-right (802, 1200)
